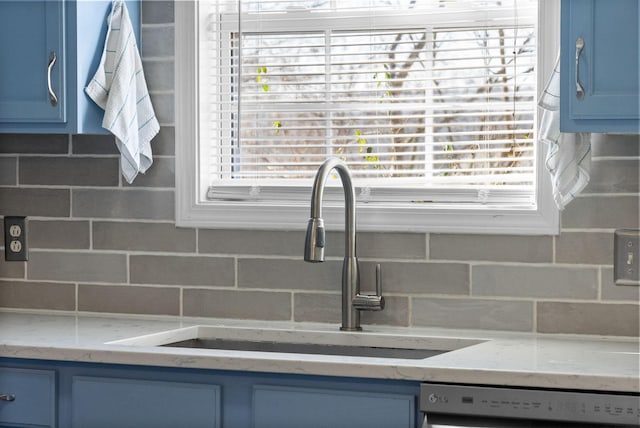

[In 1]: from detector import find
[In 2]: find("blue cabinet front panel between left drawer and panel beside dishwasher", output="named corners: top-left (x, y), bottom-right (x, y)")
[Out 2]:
top-left (71, 376), bottom-right (220, 428)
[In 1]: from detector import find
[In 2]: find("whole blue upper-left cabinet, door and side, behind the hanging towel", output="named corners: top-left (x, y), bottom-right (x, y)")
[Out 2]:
top-left (0, 0), bottom-right (140, 134)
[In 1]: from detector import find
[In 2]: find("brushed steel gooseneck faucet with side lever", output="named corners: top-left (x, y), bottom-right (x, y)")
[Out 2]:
top-left (304, 158), bottom-right (384, 331)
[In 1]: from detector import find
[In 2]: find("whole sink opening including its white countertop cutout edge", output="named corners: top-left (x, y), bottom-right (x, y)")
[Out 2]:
top-left (109, 325), bottom-right (482, 360)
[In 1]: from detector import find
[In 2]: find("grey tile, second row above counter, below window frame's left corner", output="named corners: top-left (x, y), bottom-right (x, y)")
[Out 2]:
top-left (129, 255), bottom-right (234, 287)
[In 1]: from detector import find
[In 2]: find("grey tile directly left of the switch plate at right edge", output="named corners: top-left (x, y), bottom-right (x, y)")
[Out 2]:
top-left (556, 232), bottom-right (613, 265)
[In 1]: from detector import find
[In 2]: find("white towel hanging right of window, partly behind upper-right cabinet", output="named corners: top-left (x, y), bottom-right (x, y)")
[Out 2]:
top-left (538, 56), bottom-right (591, 210)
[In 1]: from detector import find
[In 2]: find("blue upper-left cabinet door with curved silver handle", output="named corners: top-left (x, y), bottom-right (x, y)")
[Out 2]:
top-left (0, 0), bottom-right (66, 124)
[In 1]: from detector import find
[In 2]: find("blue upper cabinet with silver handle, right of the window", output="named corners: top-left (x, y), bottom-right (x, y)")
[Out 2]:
top-left (560, 0), bottom-right (640, 133)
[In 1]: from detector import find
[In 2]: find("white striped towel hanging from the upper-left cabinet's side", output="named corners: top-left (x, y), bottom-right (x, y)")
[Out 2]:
top-left (85, 0), bottom-right (160, 183)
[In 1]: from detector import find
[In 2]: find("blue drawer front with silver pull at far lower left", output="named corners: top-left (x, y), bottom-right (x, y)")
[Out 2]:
top-left (0, 368), bottom-right (56, 427)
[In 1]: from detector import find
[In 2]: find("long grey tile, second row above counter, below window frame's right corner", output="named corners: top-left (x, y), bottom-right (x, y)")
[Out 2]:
top-left (471, 265), bottom-right (598, 299)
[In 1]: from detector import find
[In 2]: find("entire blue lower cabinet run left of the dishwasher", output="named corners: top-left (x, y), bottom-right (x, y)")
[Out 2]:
top-left (0, 358), bottom-right (420, 428)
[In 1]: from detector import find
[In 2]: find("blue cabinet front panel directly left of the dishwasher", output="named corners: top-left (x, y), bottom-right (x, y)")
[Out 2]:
top-left (253, 385), bottom-right (415, 428)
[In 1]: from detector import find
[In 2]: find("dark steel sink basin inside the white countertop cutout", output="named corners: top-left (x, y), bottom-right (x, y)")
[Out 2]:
top-left (161, 339), bottom-right (447, 360)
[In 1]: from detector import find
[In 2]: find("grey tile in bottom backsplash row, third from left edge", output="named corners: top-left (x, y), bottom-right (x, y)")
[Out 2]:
top-left (183, 288), bottom-right (291, 321)
